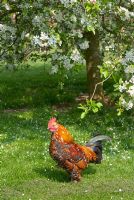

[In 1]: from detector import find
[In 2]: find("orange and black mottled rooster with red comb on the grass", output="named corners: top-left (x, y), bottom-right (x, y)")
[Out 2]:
top-left (48, 118), bottom-right (110, 182)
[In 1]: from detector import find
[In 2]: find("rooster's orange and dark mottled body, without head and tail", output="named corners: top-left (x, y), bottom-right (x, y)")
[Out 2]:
top-left (49, 125), bottom-right (96, 181)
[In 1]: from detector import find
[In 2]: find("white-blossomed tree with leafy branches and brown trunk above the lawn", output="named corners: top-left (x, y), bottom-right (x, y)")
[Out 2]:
top-left (0, 0), bottom-right (134, 113)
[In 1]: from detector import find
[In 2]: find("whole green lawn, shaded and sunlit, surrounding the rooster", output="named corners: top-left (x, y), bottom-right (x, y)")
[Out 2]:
top-left (0, 64), bottom-right (134, 200)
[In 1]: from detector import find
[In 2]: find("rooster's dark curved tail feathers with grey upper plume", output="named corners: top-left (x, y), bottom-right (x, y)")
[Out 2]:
top-left (86, 135), bottom-right (111, 164)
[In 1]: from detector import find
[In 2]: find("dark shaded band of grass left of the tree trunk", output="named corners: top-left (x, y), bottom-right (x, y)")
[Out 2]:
top-left (0, 64), bottom-right (86, 110)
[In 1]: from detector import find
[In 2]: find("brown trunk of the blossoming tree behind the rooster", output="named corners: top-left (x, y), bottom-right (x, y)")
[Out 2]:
top-left (85, 32), bottom-right (104, 99)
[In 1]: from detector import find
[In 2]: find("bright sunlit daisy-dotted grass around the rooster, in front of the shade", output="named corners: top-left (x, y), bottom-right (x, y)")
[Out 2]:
top-left (0, 107), bottom-right (134, 200)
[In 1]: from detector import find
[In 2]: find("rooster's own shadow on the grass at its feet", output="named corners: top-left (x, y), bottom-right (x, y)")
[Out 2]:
top-left (34, 166), bottom-right (96, 182)
